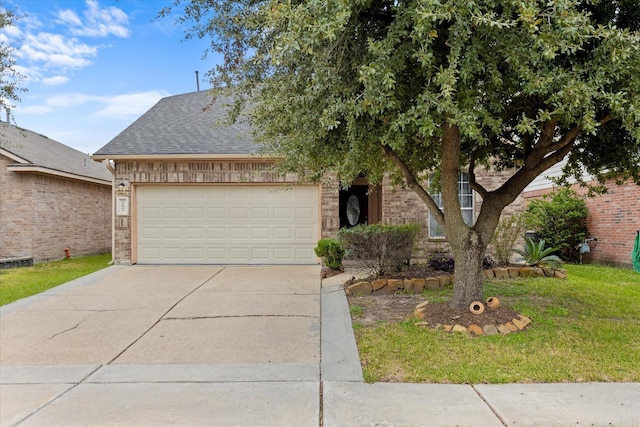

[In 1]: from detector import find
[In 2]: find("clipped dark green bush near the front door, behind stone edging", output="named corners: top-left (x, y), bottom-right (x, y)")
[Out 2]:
top-left (338, 224), bottom-right (420, 276)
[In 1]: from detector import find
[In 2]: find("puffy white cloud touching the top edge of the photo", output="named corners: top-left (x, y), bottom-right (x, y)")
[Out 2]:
top-left (58, 0), bottom-right (130, 38)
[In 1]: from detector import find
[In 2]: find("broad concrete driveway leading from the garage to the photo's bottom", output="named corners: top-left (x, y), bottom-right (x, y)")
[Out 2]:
top-left (0, 266), bottom-right (320, 426)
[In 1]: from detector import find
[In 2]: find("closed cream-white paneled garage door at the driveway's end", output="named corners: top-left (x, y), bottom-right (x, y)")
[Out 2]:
top-left (136, 185), bottom-right (319, 264)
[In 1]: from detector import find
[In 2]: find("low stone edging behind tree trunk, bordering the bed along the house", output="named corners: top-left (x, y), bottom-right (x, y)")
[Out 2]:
top-left (345, 267), bottom-right (567, 296)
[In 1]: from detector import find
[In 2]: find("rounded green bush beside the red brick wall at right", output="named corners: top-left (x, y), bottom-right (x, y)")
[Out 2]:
top-left (525, 188), bottom-right (588, 260)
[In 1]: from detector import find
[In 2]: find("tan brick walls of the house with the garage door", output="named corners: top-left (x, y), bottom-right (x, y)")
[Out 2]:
top-left (114, 159), bottom-right (524, 263)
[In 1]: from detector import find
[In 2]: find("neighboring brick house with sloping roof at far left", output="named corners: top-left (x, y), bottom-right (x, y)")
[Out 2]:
top-left (0, 123), bottom-right (112, 262)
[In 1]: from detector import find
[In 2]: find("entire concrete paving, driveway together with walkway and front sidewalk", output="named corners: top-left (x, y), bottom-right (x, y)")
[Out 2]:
top-left (0, 266), bottom-right (640, 427)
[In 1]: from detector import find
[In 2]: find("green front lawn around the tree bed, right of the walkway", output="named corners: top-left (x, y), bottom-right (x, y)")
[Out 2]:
top-left (355, 265), bottom-right (640, 384)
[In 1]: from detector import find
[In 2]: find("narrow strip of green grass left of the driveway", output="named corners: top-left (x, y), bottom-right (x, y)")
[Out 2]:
top-left (0, 254), bottom-right (111, 305)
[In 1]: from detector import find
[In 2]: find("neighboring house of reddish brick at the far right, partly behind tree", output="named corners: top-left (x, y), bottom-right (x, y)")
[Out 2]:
top-left (523, 163), bottom-right (640, 268)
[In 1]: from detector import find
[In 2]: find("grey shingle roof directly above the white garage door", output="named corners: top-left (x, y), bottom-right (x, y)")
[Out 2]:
top-left (94, 91), bottom-right (258, 157)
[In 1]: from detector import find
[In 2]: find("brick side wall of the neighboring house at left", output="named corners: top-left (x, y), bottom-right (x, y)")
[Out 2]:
top-left (0, 156), bottom-right (112, 262)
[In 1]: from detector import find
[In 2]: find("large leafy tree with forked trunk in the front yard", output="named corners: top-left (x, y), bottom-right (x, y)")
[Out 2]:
top-left (161, 0), bottom-right (640, 307)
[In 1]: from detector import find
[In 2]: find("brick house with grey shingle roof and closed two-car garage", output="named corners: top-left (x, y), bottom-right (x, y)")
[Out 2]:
top-left (93, 92), bottom-right (523, 264)
